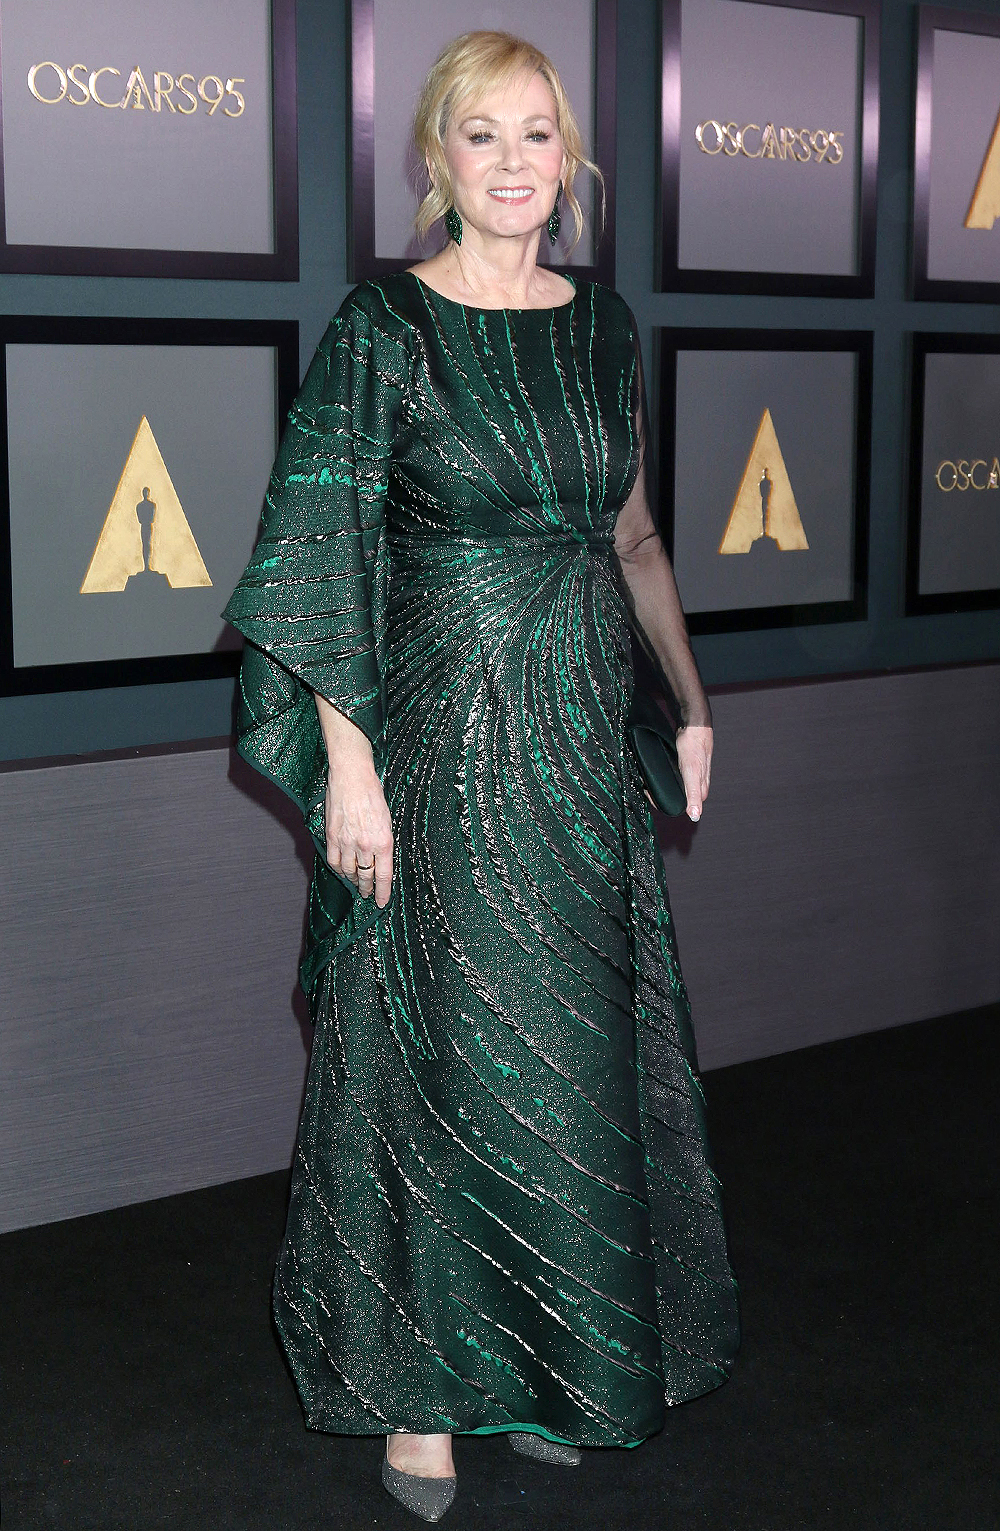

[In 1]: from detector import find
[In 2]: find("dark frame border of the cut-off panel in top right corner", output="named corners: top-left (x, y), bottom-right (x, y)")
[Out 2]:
top-left (911, 6), bottom-right (1000, 303)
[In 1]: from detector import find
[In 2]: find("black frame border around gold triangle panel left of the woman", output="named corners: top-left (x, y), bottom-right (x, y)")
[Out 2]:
top-left (0, 315), bottom-right (299, 697)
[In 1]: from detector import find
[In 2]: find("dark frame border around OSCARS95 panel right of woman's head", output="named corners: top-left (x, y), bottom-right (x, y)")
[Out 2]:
top-left (658, 0), bottom-right (881, 297)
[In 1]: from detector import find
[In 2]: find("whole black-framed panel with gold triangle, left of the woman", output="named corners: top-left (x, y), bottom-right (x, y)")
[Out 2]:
top-left (0, 318), bottom-right (297, 689)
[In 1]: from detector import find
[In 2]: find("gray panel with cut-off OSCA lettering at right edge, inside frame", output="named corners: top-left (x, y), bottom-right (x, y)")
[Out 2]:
top-left (920, 352), bottom-right (1000, 594)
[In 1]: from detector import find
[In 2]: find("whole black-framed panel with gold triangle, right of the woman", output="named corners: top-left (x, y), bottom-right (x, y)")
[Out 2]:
top-left (662, 331), bottom-right (868, 632)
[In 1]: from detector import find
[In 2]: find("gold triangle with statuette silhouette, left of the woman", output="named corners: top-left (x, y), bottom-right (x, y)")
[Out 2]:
top-left (80, 415), bottom-right (211, 596)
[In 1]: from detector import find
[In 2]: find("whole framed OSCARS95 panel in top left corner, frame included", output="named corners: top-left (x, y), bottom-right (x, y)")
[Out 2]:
top-left (0, 0), bottom-right (297, 277)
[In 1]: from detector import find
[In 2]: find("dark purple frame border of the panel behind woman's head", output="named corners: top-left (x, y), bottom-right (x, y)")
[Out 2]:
top-left (348, 0), bottom-right (617, 286)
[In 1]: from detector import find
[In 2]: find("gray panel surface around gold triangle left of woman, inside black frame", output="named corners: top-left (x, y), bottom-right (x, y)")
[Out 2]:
top-left (6, 344), bottom-right (276, 666)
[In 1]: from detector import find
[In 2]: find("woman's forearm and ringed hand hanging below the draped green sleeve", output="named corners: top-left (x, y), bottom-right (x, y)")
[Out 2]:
top-left (315, 695), bottom-right (394, 909)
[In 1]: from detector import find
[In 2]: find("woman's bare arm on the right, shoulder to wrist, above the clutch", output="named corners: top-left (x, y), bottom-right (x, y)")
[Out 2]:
top-left (614, 315), bottom-right (712, 724)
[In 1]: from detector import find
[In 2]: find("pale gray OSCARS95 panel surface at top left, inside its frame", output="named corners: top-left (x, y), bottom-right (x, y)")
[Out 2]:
top-left (0, 0), bottom-right (274, 254)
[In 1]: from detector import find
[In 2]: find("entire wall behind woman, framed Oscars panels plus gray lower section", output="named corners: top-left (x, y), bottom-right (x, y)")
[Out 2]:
top-left (0, 0), bottom-right (1000, 1223)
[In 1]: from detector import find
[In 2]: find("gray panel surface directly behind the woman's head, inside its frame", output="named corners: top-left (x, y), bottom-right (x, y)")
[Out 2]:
top-left (374, 0), bottom-right (594, 265)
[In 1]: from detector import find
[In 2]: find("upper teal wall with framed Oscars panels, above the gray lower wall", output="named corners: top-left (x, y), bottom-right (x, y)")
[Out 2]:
top-left (0, 0), bottom-right (1000, 756)
